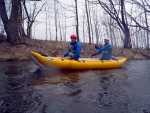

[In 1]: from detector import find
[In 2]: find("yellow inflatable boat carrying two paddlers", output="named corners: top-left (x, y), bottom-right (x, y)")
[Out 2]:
top-left (29, 51), bottom-right (127, 70)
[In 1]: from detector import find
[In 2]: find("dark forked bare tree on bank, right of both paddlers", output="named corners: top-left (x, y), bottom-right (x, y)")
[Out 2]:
top-left (98, 0), bottom-right (131, 48)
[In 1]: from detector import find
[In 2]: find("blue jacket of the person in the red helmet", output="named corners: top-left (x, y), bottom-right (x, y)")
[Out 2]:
top-left (64, 42), bottom-right (82, 60)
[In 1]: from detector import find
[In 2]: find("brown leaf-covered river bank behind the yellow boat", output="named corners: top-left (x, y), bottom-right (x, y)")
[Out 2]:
top-left (0, 39), bottom-right (150, 61)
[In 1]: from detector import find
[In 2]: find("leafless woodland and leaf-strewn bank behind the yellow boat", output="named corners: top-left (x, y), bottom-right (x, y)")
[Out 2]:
top-left (0, 0), bottom-right (150, 60)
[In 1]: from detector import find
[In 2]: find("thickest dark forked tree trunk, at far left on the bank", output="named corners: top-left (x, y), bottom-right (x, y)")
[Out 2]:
top-left (0, 0), bottom-right (21, 45)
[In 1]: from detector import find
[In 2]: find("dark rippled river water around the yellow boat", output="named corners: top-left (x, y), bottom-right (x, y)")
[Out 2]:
top-left (0, 60), bottom-right (150, 113)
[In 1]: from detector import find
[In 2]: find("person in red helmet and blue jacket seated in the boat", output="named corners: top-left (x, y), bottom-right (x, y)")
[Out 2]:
top-left (64, 34), bottom-right (82, 60)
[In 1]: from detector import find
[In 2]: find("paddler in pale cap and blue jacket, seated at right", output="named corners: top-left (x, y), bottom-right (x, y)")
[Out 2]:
top-left (91, 38), bottom-right (112, 60)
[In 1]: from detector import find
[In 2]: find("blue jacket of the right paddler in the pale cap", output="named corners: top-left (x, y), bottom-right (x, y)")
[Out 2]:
top-left (96, 44), bottom-right (112, 60)
